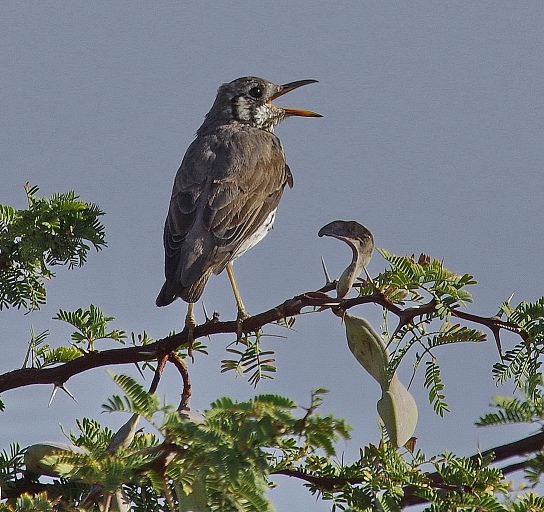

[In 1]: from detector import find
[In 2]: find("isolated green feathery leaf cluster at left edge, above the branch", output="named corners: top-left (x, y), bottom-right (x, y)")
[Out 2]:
top-left (0, 184), bottom-right (106, 310)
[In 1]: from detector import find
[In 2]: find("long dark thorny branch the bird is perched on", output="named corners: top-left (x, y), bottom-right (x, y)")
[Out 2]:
top-left (0, 283), bottom-right (525, 393)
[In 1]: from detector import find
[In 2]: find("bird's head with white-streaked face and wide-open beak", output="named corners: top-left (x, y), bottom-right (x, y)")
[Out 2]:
top-left (206, 76), bottom-right (322, 132)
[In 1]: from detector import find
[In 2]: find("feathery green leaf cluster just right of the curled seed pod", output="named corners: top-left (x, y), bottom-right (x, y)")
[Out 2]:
top-left (360, 249), bottom-right (486, 416)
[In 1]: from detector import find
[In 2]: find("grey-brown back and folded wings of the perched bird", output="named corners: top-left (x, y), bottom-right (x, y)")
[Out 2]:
top-left (164, 126), bottom-right (292, 282)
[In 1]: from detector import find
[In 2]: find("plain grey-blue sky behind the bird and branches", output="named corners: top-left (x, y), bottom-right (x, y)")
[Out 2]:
top-left (0, 0), bottom-right (544, 512)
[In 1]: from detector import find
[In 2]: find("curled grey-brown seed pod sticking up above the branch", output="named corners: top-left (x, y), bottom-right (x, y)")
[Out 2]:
top-left (317, 220), bottom-right (374, 299)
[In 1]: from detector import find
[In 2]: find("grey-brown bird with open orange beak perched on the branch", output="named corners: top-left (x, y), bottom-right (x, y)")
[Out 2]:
top-left (156, 76), bottom-right (322, 348)
